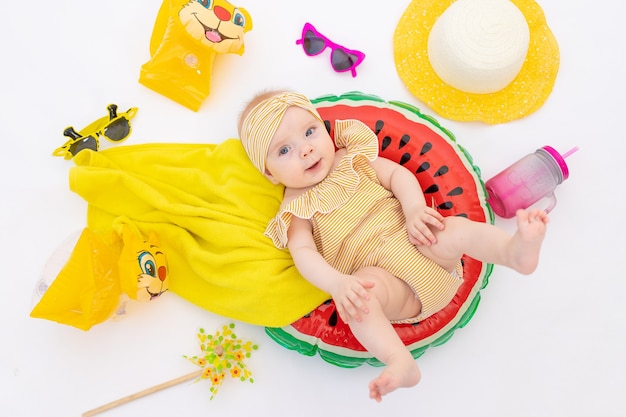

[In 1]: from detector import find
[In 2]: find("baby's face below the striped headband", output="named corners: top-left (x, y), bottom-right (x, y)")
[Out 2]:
top-left (265, 106), bottom-right (335, 189)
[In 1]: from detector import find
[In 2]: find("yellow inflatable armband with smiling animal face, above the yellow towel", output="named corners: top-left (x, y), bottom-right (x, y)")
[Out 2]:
top-left (139, 0), bottom-right (252, 111)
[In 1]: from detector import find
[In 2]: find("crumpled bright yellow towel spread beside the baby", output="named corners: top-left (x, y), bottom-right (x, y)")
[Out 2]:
top-left (70, 139), bottom-right (329, 327)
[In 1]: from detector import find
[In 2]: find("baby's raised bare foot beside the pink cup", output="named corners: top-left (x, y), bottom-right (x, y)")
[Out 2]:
top-left (511, 210), bottom-right (549, 274)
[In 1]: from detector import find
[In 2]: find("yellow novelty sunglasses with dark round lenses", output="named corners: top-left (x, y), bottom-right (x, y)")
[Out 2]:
top-left (52, 104), bottom-right (137, 159)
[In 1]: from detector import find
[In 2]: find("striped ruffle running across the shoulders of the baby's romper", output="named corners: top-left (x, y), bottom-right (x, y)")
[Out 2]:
top-left (265, 119), bottom-right (378, 249)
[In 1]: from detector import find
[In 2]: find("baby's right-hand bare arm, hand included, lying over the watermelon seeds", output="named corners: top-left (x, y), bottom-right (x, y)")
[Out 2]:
top-left (371, 158), bottom-right (443, 245)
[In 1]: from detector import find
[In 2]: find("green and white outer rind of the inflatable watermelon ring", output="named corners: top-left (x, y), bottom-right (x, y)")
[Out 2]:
top-left (265, 91), bottom-right (495, 368)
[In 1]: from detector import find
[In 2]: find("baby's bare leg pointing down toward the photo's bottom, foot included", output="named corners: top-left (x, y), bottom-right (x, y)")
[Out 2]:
top-left (348, 267), bottom-right (421, 402)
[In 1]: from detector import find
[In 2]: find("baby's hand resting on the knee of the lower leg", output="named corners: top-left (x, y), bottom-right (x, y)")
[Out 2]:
top-left (331, 275), bottom-right (374, 323)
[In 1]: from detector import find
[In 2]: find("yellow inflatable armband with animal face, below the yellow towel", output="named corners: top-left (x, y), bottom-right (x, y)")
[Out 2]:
top-left (30, 225), bottom-right (169, 330)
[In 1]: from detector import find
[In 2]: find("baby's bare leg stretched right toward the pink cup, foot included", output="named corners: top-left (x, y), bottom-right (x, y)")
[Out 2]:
top-left (419, 210), bottom-right (548, 274)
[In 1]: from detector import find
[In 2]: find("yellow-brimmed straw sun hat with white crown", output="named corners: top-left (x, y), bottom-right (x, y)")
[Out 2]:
top-left (394, 0), bottom-right (559, 124)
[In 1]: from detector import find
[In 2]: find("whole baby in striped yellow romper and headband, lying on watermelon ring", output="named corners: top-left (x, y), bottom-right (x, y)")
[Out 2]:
top-left (239, 92), bottom-right (548, 401)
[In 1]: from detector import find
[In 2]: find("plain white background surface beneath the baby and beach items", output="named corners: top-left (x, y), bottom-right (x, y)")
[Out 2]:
top-left (0, 0), bottom-right (626, 417)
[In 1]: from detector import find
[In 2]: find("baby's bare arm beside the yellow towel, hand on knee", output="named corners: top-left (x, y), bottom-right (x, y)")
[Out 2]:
top-left (287, 216), bottom-right (374, 322)
